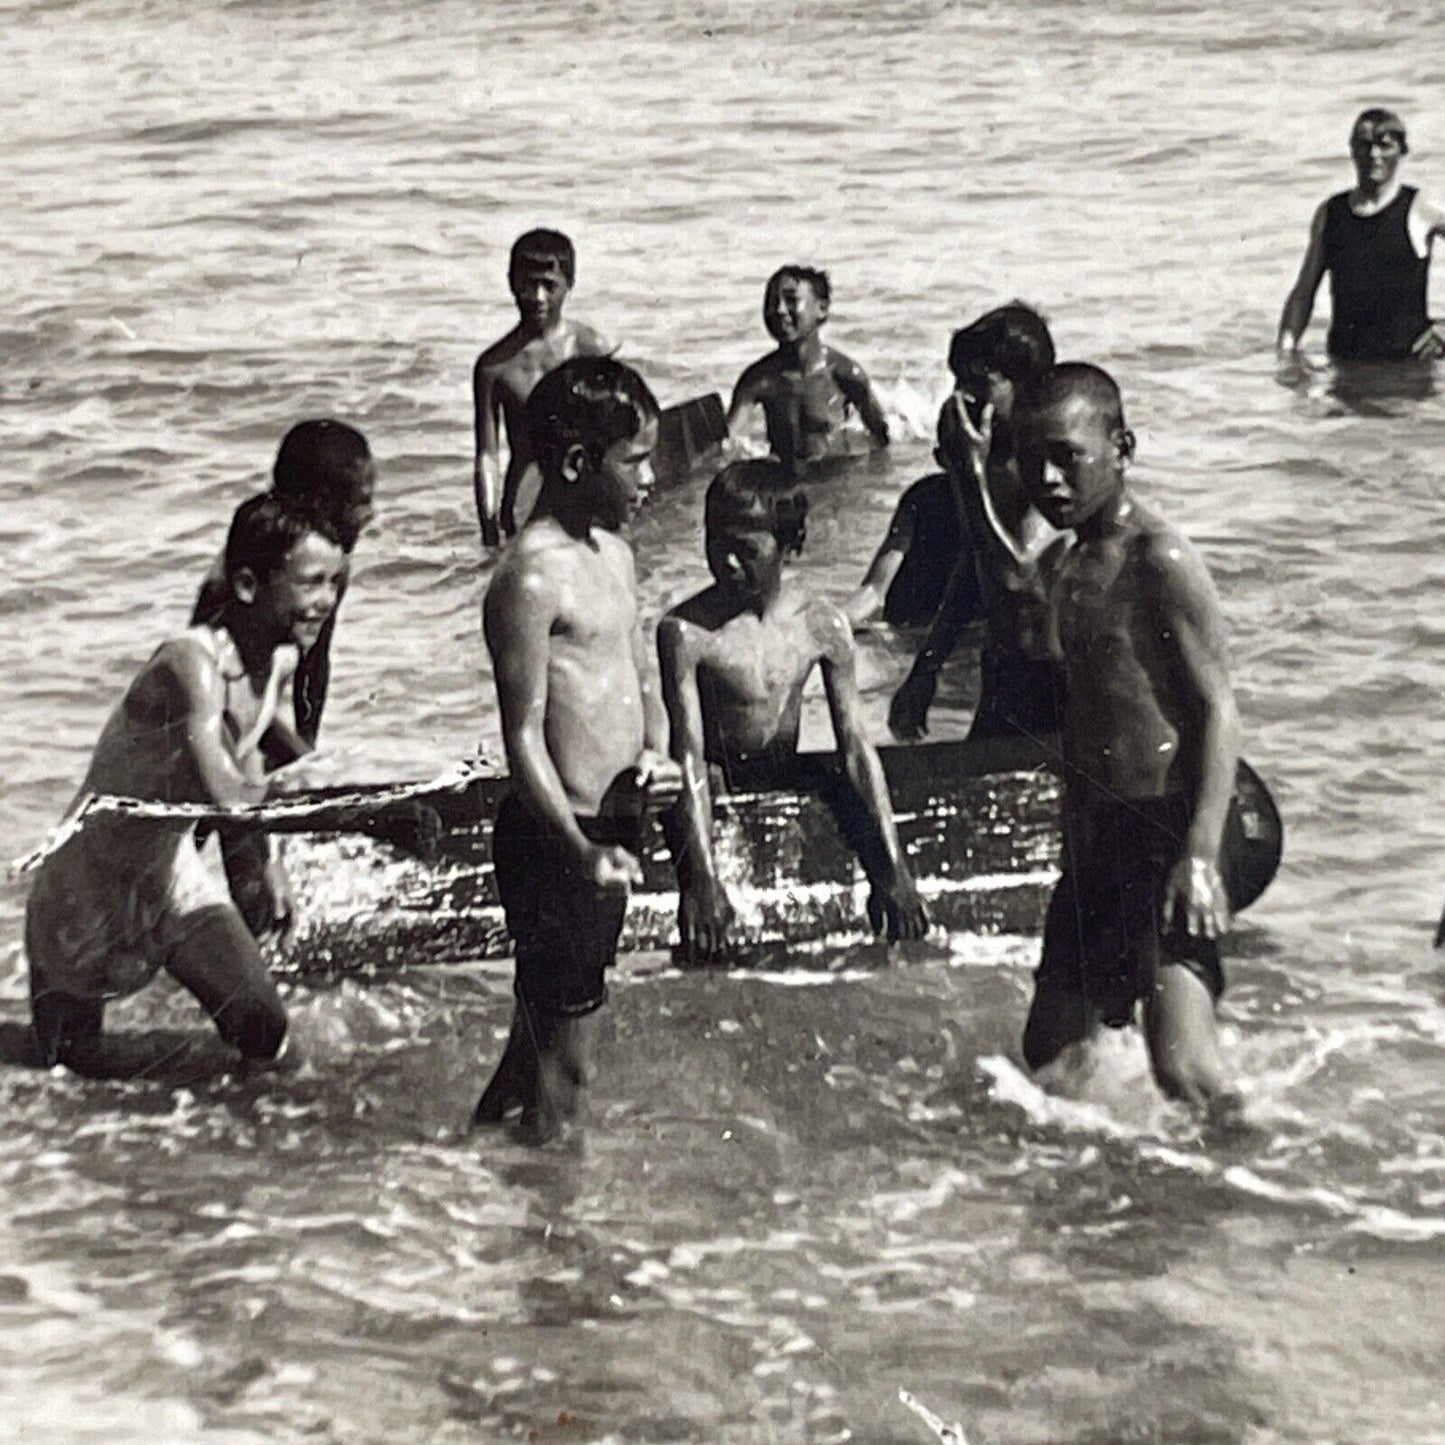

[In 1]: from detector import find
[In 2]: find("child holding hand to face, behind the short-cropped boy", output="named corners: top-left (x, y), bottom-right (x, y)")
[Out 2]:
top-left (889, 302), bottom-right (1064, 740)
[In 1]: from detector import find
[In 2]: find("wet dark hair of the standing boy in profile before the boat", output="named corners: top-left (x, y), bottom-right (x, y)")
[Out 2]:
top-left (523, 357), bottom-right (659, 480)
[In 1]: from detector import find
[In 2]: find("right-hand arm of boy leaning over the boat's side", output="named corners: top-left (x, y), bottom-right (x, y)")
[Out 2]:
top-left (808, 603), bottom-right (928, 939)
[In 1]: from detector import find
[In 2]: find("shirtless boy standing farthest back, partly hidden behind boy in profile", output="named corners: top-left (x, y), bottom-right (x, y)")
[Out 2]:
top-left (471, 230), bottom-right (611, 546)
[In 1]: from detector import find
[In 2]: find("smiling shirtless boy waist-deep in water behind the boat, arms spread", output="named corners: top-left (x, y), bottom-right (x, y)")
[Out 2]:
top-left (727, 266), bottom-right (889, 473)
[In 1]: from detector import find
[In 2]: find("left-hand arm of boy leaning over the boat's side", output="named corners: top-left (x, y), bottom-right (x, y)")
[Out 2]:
top-left (657, 616), bottom-right (733, 962)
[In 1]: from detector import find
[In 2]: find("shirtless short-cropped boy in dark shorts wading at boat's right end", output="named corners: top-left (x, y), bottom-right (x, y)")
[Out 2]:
top-left (1016, 364), bottom-right (1240, 1107)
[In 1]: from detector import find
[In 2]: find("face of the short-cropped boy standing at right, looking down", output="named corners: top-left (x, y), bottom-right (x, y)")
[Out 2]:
top-left (1017, 394), bottom-right (1124, 529)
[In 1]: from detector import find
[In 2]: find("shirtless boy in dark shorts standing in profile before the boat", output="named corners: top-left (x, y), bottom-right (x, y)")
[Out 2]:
top-left (474, 357), bottom-right (678, 1140)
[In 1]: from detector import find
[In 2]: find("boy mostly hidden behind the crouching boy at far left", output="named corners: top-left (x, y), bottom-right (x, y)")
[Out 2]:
top-left (191, 419), bottom-right (376, 933)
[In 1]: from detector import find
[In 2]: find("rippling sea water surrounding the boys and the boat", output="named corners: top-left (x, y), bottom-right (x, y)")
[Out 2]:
top-left (0, 0), bottom-right (1445, 1445)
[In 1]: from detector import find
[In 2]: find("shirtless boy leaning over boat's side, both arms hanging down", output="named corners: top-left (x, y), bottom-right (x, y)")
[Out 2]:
top-left (657, 461), bottom-right (928, 962)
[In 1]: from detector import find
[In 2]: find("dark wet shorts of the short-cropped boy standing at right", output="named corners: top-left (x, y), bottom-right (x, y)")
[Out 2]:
top-left (1036, 793), bottom-right (1240, 1027)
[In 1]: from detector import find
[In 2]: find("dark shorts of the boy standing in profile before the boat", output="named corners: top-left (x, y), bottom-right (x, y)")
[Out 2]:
top-left (491, 793), bottom-right (640, 1016)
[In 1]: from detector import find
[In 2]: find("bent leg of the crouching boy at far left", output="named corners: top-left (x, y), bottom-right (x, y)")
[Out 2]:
top-left (165, 903), bottom-right (286, 1061)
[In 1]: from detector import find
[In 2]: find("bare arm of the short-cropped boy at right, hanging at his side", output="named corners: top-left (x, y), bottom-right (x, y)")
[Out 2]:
top-left (1147, 533), bottom-right (1240, 938)
